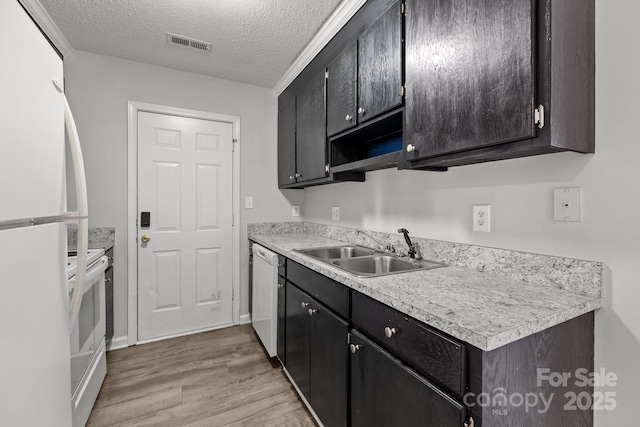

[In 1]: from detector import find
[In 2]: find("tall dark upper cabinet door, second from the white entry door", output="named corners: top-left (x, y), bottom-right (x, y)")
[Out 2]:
top-left (296, 70), bottom-right (327, 182)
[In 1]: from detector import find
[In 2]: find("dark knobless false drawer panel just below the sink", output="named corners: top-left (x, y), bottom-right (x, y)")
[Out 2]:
top-left (287, 260), bottom-right (349, 319)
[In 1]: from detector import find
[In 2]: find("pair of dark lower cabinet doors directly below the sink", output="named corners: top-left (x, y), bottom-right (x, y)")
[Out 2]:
top-left (285, 283), bottom-right (349, 427)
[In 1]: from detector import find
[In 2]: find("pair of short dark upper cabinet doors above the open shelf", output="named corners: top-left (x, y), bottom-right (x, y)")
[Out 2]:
top-left (327, 1), bottom-right (403, 136)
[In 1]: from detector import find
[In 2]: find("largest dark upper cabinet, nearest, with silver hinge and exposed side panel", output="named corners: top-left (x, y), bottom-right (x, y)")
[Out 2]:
top-left (404, 0), bottom-right (595, 169)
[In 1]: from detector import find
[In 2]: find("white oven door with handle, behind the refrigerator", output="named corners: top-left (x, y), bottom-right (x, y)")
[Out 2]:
top-left (69, 256), bottom-right (108, 394)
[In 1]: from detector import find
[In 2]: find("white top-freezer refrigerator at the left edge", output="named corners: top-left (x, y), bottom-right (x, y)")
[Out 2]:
top-left (0, 0), bottom-right (87, 427)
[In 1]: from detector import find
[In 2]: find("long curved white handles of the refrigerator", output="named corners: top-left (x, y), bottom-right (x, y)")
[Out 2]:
top-left (63, 95), bottom-right (89, 334)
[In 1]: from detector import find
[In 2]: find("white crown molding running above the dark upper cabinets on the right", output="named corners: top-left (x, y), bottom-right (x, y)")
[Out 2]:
top-left (273, 0), bottom-right (367, 96)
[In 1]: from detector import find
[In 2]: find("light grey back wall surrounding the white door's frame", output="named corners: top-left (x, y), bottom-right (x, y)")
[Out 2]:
top-left (64, 51), bottom-right (303, 338)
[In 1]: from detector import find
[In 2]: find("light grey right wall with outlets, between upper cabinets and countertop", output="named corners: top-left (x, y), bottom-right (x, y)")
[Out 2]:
top-left (303, 0), bottom-right (640, 427)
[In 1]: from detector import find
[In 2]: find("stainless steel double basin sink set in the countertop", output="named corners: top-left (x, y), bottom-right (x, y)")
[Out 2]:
top-left (297, 245), bottom-right (445, 277)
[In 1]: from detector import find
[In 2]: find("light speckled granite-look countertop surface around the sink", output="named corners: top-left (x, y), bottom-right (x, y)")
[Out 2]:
top-left (249, 232), bottom-right (602, 351)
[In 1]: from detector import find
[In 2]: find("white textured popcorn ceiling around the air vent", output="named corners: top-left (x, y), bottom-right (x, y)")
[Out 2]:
top-left (40, 0), bottom-right (340, 88)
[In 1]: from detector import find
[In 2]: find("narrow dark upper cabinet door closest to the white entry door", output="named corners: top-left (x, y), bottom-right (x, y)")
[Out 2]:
top-left (278, 96), bottom-right (296, 186)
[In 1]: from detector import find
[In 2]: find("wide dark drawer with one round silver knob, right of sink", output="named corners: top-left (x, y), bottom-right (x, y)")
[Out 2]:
top-left (352, 292), bottom-right (466, 398)
